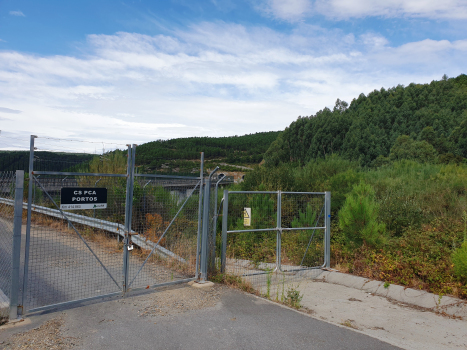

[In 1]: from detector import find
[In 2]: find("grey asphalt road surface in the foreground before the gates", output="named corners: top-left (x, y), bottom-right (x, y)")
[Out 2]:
top-left (0, 285), bottom-right (399, 350)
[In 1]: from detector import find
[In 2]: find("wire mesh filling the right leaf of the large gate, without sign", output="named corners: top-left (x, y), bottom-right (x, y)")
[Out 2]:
top-left (128, 175), bottom-right (199, 288)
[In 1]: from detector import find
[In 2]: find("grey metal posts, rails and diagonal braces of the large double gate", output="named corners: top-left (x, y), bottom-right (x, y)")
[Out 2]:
top-left (10, 135), bottom-right (207, 320)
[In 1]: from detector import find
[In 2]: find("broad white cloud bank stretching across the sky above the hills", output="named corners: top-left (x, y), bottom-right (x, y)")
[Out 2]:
top-left (0, 22), bottom-right (467, 148)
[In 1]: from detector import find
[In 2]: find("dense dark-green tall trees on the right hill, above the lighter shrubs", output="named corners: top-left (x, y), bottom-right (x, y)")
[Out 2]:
top-left (265, 74), bottom-right (467, 166)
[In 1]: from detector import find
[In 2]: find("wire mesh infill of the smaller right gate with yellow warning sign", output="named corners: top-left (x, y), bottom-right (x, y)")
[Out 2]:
top-left (225, 192), bottom-right (325, 300)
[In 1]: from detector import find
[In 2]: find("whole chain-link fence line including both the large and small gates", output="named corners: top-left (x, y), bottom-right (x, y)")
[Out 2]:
top-left (0, 137), bottom-right (330, 317)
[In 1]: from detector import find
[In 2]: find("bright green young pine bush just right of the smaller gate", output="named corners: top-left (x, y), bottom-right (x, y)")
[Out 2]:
top-left (339, 182), bottom-right (386, 247)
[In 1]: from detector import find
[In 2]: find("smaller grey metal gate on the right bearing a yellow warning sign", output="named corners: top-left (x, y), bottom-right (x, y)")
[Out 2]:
top-left (220, 190), bottom-right (331, 287)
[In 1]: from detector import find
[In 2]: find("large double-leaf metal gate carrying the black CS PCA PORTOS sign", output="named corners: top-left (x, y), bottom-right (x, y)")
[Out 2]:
top-left (5, 136), bottom-right (204, 317)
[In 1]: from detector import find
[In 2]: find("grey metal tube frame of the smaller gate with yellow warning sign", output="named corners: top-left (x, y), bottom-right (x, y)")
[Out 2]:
top-left (221, 190), bottom-right (331, 274)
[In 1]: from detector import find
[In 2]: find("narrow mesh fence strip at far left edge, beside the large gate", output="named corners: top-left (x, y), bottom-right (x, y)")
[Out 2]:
top-left (0, 172), bottom-right (16, 323)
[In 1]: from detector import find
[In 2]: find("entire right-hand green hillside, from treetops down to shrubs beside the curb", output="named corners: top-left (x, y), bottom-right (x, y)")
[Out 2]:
top-left (236, 75), bottom-right (467, 298)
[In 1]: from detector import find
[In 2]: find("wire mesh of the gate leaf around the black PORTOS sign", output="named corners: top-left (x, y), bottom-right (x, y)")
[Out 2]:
top-left (25, 175), bottom-right (126, 309)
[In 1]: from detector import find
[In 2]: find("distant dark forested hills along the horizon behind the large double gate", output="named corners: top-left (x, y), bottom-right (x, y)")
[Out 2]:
top-left (0, 131), bottom-right (280, 175)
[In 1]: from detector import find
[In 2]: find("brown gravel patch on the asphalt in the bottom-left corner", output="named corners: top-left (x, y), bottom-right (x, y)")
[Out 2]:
top-left (0, 315), bottom-right (80, 350)
